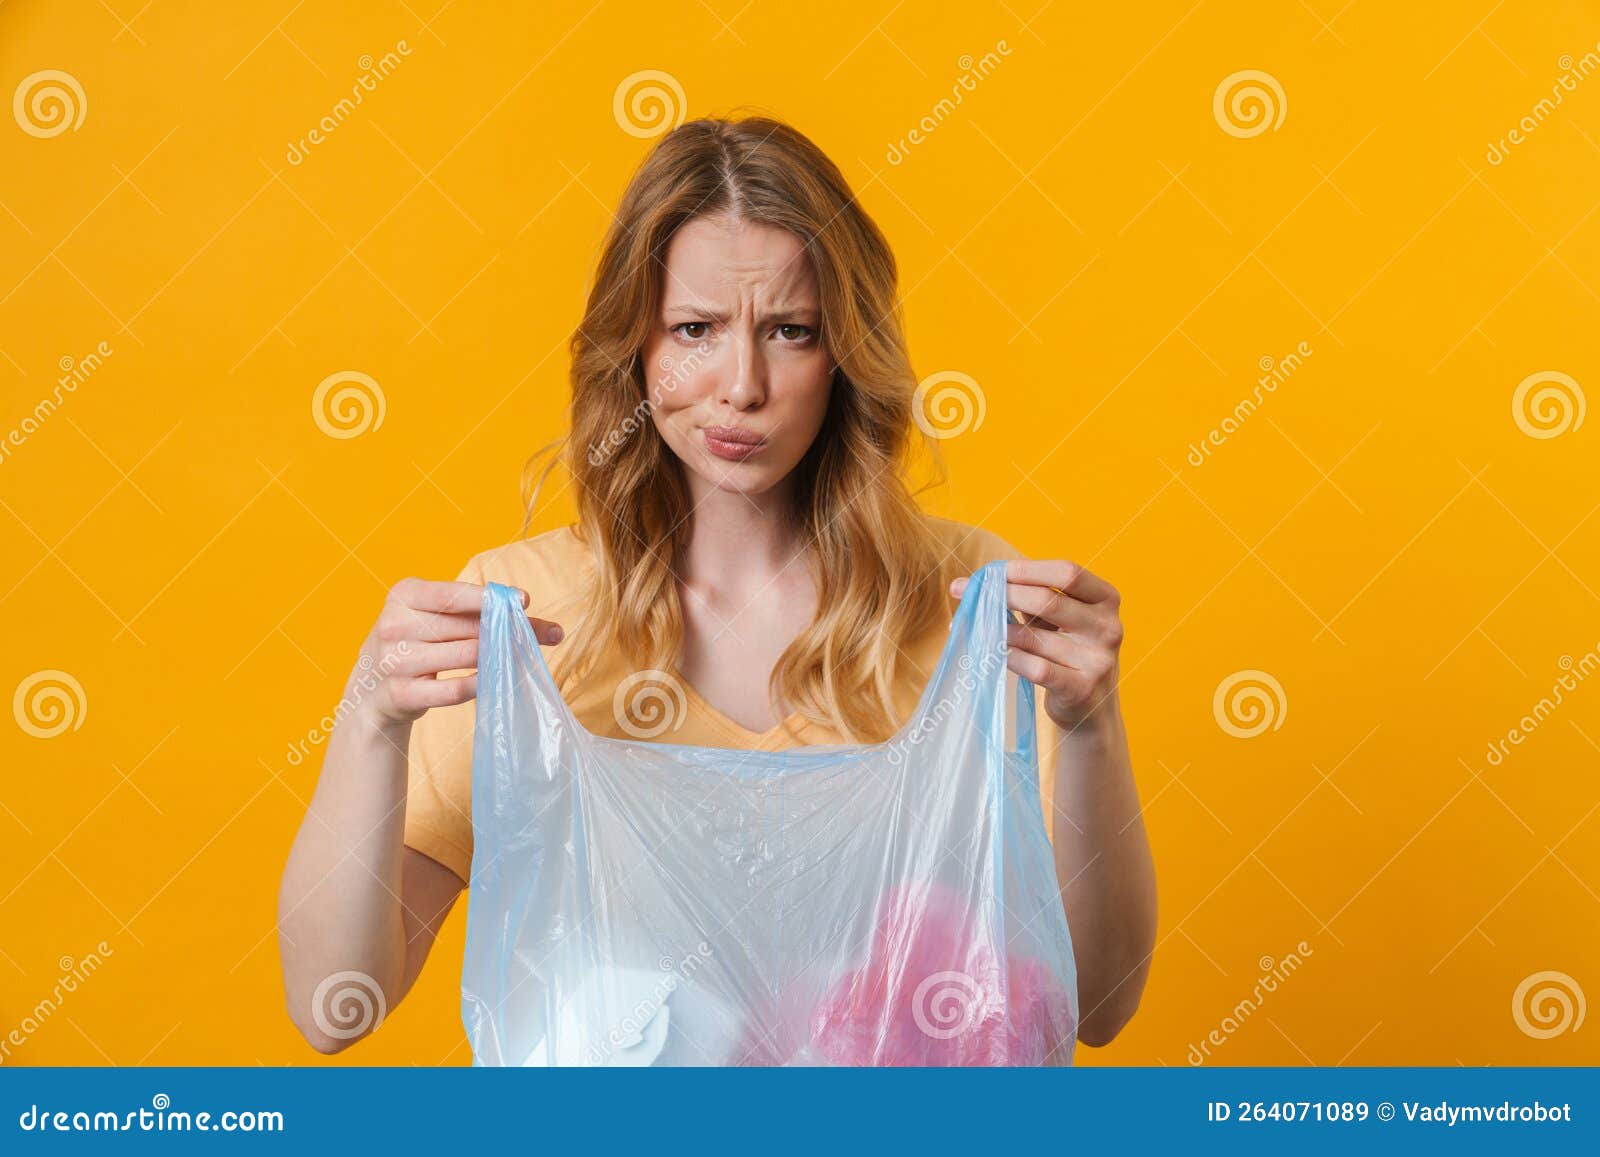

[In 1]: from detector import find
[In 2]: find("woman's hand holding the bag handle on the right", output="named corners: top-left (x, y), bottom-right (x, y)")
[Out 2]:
top-left (950, 558), bottom-right (1122, 731)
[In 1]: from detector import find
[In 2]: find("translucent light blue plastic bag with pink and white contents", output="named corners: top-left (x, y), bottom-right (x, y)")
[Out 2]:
top-left (461, 560), bottom-right (1078, 1066)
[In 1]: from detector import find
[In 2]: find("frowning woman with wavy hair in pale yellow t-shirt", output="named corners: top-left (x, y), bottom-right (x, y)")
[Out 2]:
top-left (280, 117), bottom-right (1155, 1053)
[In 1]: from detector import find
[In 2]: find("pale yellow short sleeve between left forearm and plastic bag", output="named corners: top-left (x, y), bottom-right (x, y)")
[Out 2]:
top-left (405, 558), bottom-right (483, 882)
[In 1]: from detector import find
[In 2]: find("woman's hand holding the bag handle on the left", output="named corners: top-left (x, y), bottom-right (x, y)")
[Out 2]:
top-left (352, 578), bottom-right (563, 730)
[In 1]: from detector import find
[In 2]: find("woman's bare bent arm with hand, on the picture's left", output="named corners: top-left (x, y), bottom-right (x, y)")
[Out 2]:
top-left (278, 579), bottom-right (560, 1053)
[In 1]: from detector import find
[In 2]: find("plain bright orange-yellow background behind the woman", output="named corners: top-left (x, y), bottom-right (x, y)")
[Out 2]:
top-left (0, 0), bottom-right (1600, 1066)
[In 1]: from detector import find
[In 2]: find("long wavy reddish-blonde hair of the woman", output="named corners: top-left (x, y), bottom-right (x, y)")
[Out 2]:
top-left (523, 108), bottom-right (950, 743)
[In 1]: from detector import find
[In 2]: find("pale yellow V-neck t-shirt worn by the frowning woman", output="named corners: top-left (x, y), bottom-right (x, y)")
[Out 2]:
top-left (405, 515), bottom-right (1059, 880)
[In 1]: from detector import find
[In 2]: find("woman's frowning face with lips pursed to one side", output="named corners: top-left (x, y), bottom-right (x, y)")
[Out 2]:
top-left (643, 216), bottom-right (834, 502)
